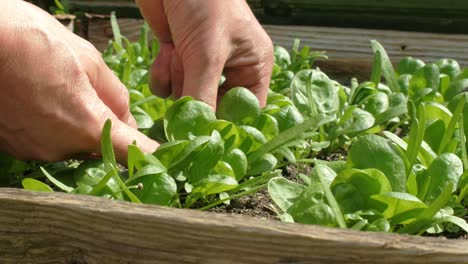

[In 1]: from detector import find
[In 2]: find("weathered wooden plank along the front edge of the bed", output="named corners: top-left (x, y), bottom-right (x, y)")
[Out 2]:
top-left (0, 189), bottom-right (468, 264)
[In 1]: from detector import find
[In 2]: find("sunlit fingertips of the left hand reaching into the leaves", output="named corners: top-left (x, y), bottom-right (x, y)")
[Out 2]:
top-left (112, 117), bottom-right (159, 164)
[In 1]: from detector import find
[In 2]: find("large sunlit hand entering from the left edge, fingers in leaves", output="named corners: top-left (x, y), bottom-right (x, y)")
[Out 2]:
top-left (0, 0), bottom-right (158, 161)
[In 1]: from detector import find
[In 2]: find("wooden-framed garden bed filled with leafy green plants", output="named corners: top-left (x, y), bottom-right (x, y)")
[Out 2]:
top-left (0, 8), bottom-right (468, 263)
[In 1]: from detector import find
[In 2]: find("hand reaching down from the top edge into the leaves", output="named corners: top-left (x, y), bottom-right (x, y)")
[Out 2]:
top-left (136, 0), bottom-right (273, 108)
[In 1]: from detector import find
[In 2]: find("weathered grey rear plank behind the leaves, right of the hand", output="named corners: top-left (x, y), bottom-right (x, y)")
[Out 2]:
top-left (264, 25), bottom-right (468, 80)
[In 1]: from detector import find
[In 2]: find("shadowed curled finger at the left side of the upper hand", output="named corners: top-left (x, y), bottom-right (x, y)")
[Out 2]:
top-left (151, 43), bottom-right (174, 97)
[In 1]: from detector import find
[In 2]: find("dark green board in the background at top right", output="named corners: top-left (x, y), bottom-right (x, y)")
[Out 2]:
top-left (260, 0), bottom-right (468, 33)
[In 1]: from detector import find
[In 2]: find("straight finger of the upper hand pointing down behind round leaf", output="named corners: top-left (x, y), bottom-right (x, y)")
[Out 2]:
top-left (182, 52), bottom-right (226, 109)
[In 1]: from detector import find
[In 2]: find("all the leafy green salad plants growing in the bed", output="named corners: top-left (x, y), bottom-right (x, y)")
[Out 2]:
top-left (0, 14), bottom-right (468, 237)
